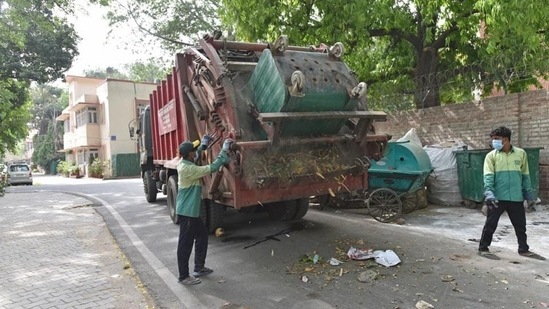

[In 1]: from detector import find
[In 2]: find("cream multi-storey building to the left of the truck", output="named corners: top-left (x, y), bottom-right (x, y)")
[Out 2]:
top-left (57, 75), bottom-right (156, 178)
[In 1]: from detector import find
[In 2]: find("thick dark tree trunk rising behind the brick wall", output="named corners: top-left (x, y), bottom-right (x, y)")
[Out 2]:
top-left (414, 47), bottom-right (440, 109)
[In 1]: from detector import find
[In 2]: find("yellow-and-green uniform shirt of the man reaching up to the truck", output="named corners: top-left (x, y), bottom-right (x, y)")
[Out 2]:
top-left (176, 151), bottom-right (229, 218)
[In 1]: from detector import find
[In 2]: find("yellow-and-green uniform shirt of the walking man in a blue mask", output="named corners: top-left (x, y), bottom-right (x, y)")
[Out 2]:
top-left (484, 146), bottom-right (532, 202)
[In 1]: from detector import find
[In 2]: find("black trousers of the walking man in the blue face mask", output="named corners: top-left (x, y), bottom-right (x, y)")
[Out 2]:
top-left (478, 201), bottom-right (529, 253)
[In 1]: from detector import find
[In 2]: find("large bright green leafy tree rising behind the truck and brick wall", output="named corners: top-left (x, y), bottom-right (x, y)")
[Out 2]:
top-left (221, 0), bottom-right (549, 108)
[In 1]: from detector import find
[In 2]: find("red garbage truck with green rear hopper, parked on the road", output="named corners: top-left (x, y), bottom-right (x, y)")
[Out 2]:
top-left (136, 35), bottom-right (386, 232)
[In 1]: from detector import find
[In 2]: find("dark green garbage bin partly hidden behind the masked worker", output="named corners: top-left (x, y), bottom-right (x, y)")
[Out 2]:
top-left (454, 147), bottom-right (543, 208)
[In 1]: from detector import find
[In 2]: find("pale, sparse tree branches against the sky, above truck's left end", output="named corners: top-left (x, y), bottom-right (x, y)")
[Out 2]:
top-left (103, 0), bottom-right (220, 52)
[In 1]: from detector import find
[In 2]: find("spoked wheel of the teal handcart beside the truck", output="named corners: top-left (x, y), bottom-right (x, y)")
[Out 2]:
top-left (367, 188), bottom-right (402, 223)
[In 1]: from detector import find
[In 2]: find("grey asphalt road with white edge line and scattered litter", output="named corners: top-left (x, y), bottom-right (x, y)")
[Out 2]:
top-left (20, 175), bottom-right (549, 308)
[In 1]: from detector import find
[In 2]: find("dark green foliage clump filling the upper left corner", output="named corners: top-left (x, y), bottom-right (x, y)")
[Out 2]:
top-left (0, 0), bottom-right (78, 83)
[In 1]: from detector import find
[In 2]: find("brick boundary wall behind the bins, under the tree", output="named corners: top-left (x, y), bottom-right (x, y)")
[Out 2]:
top-left (375, 90), bottom-right (549, 201)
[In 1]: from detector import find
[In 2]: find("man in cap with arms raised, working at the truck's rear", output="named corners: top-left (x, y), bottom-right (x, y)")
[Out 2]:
top-left (176, 135), bottom-right (233, 285)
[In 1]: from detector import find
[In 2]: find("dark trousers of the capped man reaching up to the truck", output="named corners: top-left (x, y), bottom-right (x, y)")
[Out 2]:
top-left (177, 216), bottom-right (208, 280)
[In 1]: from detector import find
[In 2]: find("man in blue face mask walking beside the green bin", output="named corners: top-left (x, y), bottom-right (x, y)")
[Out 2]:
top-left (478, 127), bottom-right (544, 259)
